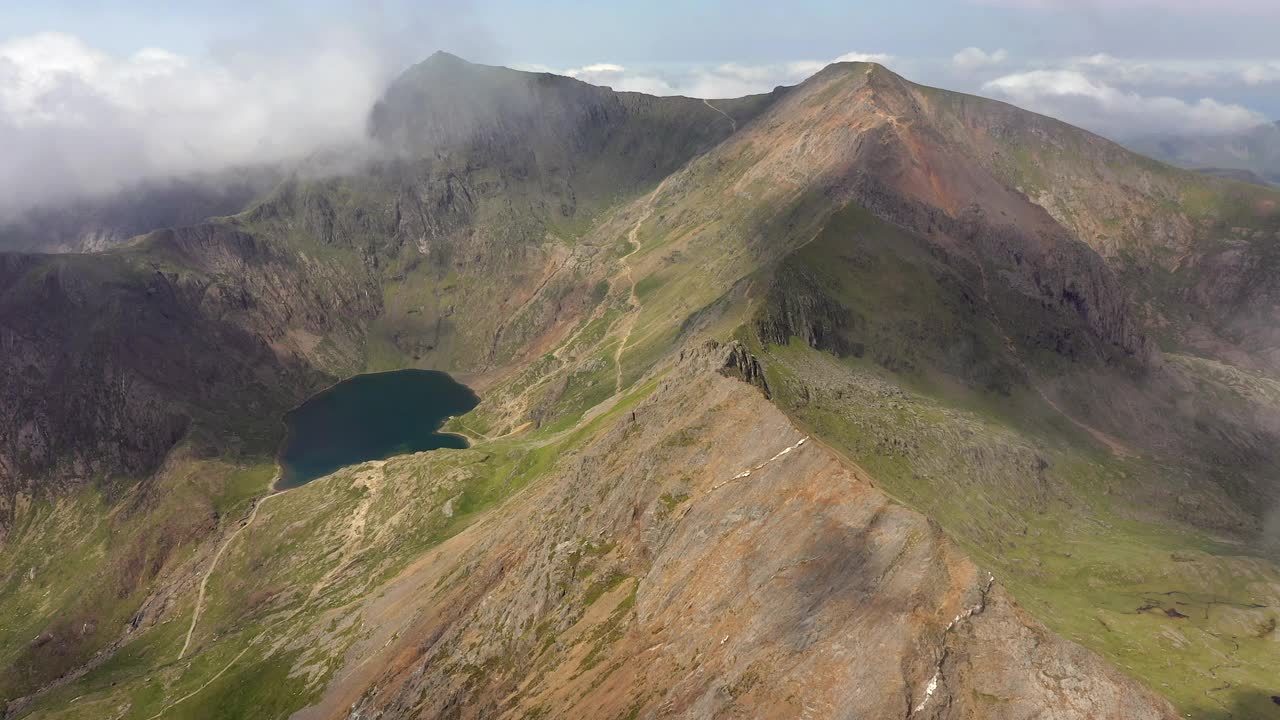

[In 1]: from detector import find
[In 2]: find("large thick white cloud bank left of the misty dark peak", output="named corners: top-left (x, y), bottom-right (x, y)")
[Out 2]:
top-left (0, 33), bottom-right (385, 214)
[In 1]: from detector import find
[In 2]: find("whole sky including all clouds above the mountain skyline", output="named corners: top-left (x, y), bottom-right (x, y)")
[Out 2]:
top-left (0, 0), bottom-right (1280, 215)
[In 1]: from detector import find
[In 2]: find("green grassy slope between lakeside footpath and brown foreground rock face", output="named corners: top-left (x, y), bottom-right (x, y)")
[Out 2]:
top-left (10, 368), bottom-right (654, 719)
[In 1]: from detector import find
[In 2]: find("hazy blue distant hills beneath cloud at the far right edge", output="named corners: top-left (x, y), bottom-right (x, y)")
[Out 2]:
top-left (1129, 123), bottom-right (1280, 184)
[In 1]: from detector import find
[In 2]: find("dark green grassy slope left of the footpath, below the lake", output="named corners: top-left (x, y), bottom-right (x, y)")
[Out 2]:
top-left (0, 454), bottom-right (274, 697)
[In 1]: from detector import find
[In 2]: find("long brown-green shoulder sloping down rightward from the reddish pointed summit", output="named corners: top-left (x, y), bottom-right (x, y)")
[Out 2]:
top-left (911, 75), bottom-right (1280, 369)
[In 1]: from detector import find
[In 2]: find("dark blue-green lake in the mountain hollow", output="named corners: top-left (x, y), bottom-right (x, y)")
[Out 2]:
top-left (276, 370), bottom-right (480, 489)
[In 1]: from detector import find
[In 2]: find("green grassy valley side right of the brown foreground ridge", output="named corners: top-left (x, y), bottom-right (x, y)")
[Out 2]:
top-left (767, 343), bottom-right (1280, 717)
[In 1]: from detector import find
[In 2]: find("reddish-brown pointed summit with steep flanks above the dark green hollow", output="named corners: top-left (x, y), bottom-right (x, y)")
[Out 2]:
top-left (604, 64), bottom-right (1152, 392)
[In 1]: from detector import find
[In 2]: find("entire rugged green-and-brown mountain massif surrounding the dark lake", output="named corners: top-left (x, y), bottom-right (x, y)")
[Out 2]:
top-left (0, 54), bottom-right (1280, 719)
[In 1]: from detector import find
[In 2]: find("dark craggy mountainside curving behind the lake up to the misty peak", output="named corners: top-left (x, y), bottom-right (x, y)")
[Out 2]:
top-left (0, 54), bottom-right (755, 517)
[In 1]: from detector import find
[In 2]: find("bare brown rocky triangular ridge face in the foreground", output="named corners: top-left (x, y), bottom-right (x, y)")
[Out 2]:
top-left (298, 345), bottom-right (1176, 720)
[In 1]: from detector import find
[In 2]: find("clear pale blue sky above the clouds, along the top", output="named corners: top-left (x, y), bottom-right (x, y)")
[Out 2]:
top-left (15, 0), bottom-right (1280, 64)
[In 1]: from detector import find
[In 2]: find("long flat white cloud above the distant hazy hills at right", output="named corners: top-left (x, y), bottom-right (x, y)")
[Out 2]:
top-left (983, 69), bottom-right (1266, 135)
